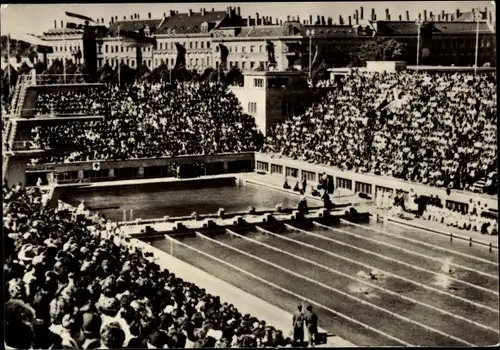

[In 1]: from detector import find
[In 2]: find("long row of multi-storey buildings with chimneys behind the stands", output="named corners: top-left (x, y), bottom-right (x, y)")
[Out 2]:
top-left (38, 7), bottom-right (496, 72)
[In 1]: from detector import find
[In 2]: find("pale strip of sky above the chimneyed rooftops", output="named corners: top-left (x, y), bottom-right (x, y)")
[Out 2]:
top-left (0, 1), bottom-right (495, 35)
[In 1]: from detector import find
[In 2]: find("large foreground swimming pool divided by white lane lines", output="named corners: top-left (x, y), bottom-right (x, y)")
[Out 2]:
top-left (151, 221), bottom-right (499, 346)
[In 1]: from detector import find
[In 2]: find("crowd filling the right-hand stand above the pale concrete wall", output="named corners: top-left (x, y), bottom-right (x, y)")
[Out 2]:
top-left (263, 71), bottom-right (498, 194)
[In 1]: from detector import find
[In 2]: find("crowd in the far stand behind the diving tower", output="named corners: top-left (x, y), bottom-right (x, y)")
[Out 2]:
top-left (33, 82), bottom-right (262, 162)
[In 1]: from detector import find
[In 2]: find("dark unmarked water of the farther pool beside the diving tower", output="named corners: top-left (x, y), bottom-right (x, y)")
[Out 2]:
top-left (59, 180), bottom-right (321, 221)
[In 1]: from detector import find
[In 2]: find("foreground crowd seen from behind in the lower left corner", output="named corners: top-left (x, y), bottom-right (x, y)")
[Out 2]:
top-left (3, 185), bottom-right (291, 349)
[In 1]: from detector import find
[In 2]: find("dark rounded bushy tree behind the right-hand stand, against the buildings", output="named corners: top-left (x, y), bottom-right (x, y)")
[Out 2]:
top-left (359, 38), bottom-right (405, 63)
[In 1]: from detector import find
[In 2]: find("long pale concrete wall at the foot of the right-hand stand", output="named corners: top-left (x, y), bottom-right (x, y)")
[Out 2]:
top-left (255, 153), bottom-right (498, 209)
